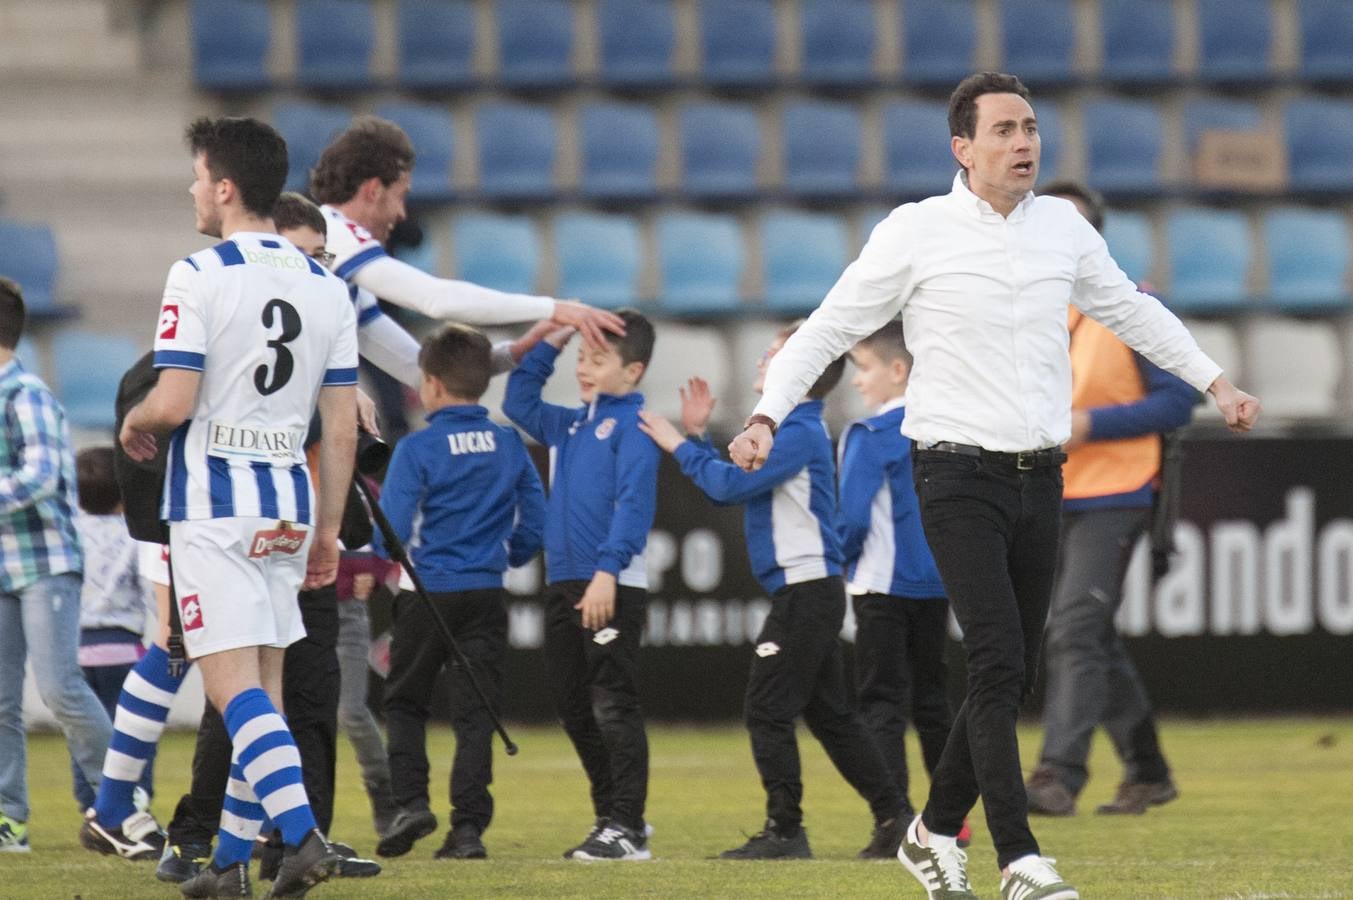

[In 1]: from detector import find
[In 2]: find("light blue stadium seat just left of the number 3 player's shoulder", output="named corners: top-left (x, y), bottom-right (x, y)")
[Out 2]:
top-left (51, 329), bottom-right (149, 429)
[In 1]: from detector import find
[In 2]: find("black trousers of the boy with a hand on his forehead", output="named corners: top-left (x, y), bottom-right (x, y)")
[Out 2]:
top-left (545, 581), bottom-right (648, 831)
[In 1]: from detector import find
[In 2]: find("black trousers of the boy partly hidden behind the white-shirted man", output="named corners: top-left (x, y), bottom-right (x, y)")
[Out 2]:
top-left (851, 594), bottom-right (954, 807)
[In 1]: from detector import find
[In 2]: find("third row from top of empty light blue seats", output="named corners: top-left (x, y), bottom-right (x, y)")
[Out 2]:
top-left (395, 207), bottom-right (1353, 317)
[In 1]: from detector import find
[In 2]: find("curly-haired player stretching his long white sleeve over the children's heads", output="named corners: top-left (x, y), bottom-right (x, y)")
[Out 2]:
top-left (310, 116), bottom-right (624, 387)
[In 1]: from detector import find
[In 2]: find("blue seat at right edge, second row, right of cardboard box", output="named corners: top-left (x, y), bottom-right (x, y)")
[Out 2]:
top-left (1283, 96), bottom-right (1353, 194)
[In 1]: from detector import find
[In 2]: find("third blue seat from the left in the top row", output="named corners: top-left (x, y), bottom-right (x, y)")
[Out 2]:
top-left (396, 0), bottom-right (476, 89)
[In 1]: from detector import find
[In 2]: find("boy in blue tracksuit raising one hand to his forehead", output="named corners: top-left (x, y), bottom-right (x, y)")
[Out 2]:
top-left (503, 310), bottom-right (659, 859)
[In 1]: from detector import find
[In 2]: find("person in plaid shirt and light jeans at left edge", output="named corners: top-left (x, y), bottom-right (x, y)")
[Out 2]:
top-left (0, 277), bottom-right (112, 853)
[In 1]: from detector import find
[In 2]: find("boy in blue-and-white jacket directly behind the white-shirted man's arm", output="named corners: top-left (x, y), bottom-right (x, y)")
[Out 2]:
top-left (838, 321), bottom-right (963, 851)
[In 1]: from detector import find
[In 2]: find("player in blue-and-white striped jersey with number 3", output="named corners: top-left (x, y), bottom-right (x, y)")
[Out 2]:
top-left (109, 118), bottom-right (357, 896)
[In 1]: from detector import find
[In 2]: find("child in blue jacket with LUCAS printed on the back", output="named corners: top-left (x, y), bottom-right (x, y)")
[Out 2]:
top-left (376, 325), bottom-right (545, 859)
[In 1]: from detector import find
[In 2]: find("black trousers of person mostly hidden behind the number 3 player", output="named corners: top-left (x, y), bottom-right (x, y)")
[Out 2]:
top-left (168, 585), bottom-right (338, 845)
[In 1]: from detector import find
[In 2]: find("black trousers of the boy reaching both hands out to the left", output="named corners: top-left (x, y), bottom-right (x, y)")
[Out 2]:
top-left (743, 577), bottom-right (905, 835)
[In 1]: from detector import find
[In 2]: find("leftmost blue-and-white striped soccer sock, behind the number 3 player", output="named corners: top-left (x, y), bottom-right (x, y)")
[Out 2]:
top-left (93, 644), bottom-right (187, 828)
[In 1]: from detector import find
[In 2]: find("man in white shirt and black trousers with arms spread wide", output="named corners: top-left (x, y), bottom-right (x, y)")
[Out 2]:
top-left (729, 73), bottom-right (1260, 900)
